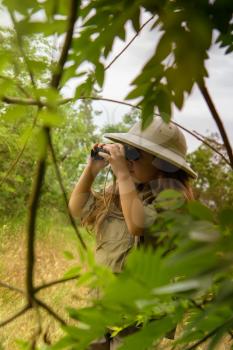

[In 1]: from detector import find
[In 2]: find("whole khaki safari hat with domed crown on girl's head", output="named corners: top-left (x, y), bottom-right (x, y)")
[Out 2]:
top-left (104, 117), bottom-right (197, 179)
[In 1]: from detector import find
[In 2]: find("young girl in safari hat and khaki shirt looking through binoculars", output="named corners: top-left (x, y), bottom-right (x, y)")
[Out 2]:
top-left (69, 117), bottom-right (196, 349)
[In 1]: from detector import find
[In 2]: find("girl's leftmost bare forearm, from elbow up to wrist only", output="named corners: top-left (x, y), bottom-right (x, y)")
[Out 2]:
top-left (69, 165), bottom-right (97, 217)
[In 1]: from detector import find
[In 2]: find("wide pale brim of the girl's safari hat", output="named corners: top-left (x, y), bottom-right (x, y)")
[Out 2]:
top-left (104, 133), bottom-right (197, 179)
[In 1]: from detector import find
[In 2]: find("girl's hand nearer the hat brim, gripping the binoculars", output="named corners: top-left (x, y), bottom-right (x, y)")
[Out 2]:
top-left (99, 143), bottom-right (129, 177)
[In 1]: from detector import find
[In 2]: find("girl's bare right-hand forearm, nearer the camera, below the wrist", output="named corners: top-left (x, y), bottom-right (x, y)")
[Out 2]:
top-left (118, 174), bottom-right (145, 236)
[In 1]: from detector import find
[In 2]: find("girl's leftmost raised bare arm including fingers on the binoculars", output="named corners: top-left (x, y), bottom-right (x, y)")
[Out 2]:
top-left (69, 144), bottom-right (106, 217)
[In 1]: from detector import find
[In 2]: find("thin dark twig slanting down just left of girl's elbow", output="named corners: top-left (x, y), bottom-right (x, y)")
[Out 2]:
top-left (48, 135), bottom-right (87, 249)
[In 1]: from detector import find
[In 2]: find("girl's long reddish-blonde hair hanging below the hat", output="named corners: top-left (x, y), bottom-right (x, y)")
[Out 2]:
top-left (81, 161), bottom-right (194, 234)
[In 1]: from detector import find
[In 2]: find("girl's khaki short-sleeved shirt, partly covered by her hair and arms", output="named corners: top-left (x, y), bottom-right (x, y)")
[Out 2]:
top-left (81, 189), bottom-right (157, 273)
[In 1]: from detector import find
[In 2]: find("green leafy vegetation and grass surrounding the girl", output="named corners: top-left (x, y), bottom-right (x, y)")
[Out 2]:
top-left (0, 0), bottom-right (233, 350)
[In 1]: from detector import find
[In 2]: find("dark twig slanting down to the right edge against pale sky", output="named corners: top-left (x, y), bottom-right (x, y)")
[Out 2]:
top-left (198, 83), bottom-right (233, 169)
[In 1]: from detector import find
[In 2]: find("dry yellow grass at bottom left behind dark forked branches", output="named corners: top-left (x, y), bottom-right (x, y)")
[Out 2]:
top-left (0, 215), bottom-right (91, 350)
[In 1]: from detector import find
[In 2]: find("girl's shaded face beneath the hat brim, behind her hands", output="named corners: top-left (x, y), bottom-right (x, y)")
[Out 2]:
top-left (127, 146), bottom-right (158, 183)
